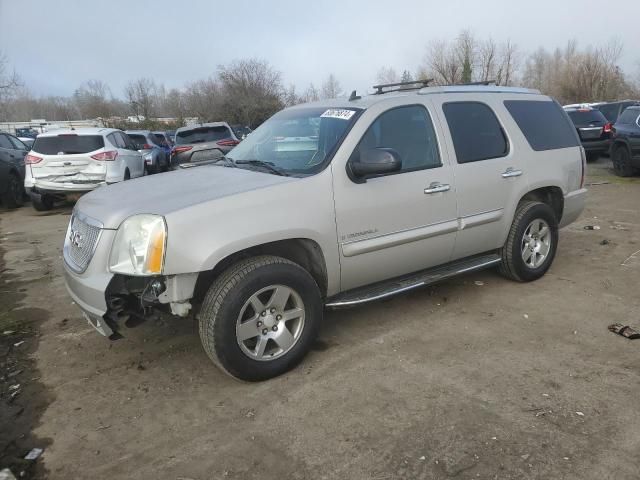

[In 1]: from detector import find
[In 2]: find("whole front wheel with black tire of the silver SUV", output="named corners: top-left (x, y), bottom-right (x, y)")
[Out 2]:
top-left (199, 256), bottom-right (323, 382)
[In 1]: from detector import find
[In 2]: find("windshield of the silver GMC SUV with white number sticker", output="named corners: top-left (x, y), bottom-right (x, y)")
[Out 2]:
top-left (228, 107), bottom-right (360, 175)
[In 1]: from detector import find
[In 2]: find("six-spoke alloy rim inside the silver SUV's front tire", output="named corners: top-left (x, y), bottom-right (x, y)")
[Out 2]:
top-left (236, 285), bottom-right (305, 361)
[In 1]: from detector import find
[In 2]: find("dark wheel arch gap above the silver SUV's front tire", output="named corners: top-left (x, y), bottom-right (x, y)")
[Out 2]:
top-left (193, 238), bottom-right (328, 301)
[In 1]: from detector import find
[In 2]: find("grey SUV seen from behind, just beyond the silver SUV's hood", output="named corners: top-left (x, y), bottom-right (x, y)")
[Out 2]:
top-left (171, 122), bottom-right (240, 168)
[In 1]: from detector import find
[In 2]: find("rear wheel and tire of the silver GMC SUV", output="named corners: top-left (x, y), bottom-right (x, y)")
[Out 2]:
top-left (498, 201), bottom-right (558, 282)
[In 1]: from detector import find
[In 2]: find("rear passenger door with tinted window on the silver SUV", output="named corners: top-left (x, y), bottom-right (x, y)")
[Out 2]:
top-left (433, 95), bottom-right (526, 259)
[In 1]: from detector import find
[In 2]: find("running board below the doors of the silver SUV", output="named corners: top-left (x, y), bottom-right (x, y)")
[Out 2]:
top-left (325, 253), bottom-right (500, 308)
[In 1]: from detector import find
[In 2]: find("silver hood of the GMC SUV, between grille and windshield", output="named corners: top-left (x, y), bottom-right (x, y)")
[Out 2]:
top-left (75, 166), bottom-right (296, 229)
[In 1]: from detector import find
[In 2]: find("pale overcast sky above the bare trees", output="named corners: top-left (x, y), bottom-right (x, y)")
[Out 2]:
top-left (0, 0), bottom-right (640, 97)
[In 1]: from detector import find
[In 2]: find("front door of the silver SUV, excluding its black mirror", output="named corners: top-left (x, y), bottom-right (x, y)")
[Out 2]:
top-left (332, 103), bottom-right (458, 290)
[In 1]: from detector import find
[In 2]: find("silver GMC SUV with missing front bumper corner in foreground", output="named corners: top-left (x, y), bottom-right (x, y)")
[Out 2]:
top-left (64, 86), bottom-right (586, 381)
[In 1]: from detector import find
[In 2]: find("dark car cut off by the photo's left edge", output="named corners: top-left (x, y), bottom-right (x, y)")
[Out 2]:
top-left (0, 133), bottom-right (29, 208)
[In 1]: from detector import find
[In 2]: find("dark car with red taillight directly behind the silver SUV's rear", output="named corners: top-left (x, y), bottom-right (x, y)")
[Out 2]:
top-left (564, 107), bottom-right (613, 161)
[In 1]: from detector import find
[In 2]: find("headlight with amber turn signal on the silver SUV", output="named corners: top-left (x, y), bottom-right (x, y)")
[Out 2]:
top-left (109, 214), bottom-right (167, 276)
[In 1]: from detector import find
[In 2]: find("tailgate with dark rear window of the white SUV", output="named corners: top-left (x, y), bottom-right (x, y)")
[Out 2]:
top-left (30, 133), bottom-right (106, 183)
